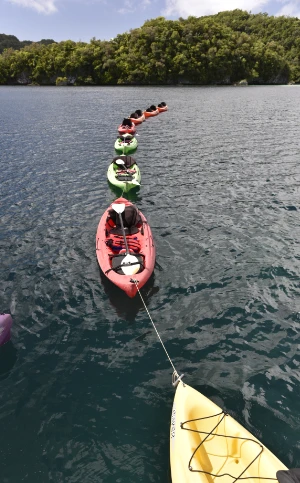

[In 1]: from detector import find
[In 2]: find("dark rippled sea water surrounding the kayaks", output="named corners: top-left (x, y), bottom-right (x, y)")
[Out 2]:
top-left (0, 86), bottom-right (300, 483)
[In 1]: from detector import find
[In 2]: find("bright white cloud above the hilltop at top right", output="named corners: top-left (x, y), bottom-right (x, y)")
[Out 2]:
top-left (162, 0), bottom-right (300, 18)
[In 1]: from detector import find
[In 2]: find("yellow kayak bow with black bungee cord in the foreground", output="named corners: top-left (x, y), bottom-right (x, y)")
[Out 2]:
top-left (170, 381), bottom-right (287, 483)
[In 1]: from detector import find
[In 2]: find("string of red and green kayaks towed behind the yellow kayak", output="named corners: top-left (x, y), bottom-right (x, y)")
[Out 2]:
top-left (96, 102), bottom-right (168, 297)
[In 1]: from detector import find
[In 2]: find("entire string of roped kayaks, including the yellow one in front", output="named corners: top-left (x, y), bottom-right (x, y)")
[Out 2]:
top-left (96, 103), bottom-right (300, 483)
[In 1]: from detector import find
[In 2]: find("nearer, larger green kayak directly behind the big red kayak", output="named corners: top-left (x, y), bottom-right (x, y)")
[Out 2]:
top-left (107, 156), bottom-right (141, 193)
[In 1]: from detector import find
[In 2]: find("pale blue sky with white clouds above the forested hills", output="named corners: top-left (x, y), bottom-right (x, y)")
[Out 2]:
top-left (0, 0), bottom-right (300, 42)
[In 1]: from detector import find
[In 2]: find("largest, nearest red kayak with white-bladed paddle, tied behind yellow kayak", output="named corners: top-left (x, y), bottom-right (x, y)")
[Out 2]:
top-left (96, 198), bottom-right (155, 297)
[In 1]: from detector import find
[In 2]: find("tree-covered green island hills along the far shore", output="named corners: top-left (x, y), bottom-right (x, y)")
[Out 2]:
top-left (0, 9), bottom-right (300, 85)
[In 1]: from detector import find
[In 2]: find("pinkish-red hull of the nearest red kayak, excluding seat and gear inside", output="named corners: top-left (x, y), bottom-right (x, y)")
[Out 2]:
top-left (96, 198), bottom-right (156, 298)
